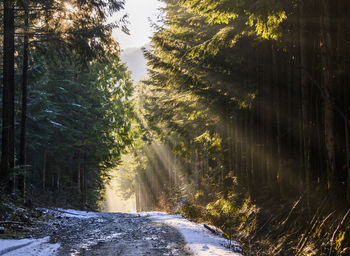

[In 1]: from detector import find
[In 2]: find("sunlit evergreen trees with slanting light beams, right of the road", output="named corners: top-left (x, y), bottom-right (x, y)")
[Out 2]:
top-left (126, 0), bottom-right (350, 255)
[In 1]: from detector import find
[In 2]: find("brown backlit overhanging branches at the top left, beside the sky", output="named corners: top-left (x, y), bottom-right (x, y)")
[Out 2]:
top-left (29, 0), bottom-right (127, 60)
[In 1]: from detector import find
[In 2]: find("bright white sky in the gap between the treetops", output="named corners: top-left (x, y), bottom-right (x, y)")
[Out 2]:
top-left (113, 0), bottom-right (164, 49)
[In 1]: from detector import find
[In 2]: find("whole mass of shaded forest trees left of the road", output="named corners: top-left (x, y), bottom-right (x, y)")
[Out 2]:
top-left (0, 0), bottom-right (135, 208)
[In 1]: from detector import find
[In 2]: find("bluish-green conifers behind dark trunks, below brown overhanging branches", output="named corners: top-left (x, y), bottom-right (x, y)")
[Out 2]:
top-left (11, 40), bottom-right (135, 207)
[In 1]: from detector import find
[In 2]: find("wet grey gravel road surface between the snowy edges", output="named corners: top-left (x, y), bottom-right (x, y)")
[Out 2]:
top-left (35, 213), bottom-right (191, 256)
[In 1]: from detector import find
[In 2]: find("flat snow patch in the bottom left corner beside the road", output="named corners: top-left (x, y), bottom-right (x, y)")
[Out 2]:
top-left (0, 237), bottom-right (60, 256)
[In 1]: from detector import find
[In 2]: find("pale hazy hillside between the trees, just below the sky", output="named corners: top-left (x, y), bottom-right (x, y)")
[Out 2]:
top-left (121, 46), bottom-right (148, 81)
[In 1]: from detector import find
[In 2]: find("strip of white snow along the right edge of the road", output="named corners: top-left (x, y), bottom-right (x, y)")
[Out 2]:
top-left (140, 212), bottom-right (242, 256)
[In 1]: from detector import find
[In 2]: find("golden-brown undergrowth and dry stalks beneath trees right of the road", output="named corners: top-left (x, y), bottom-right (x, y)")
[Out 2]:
top-left (175, 186), bottom-right (350, 256)
